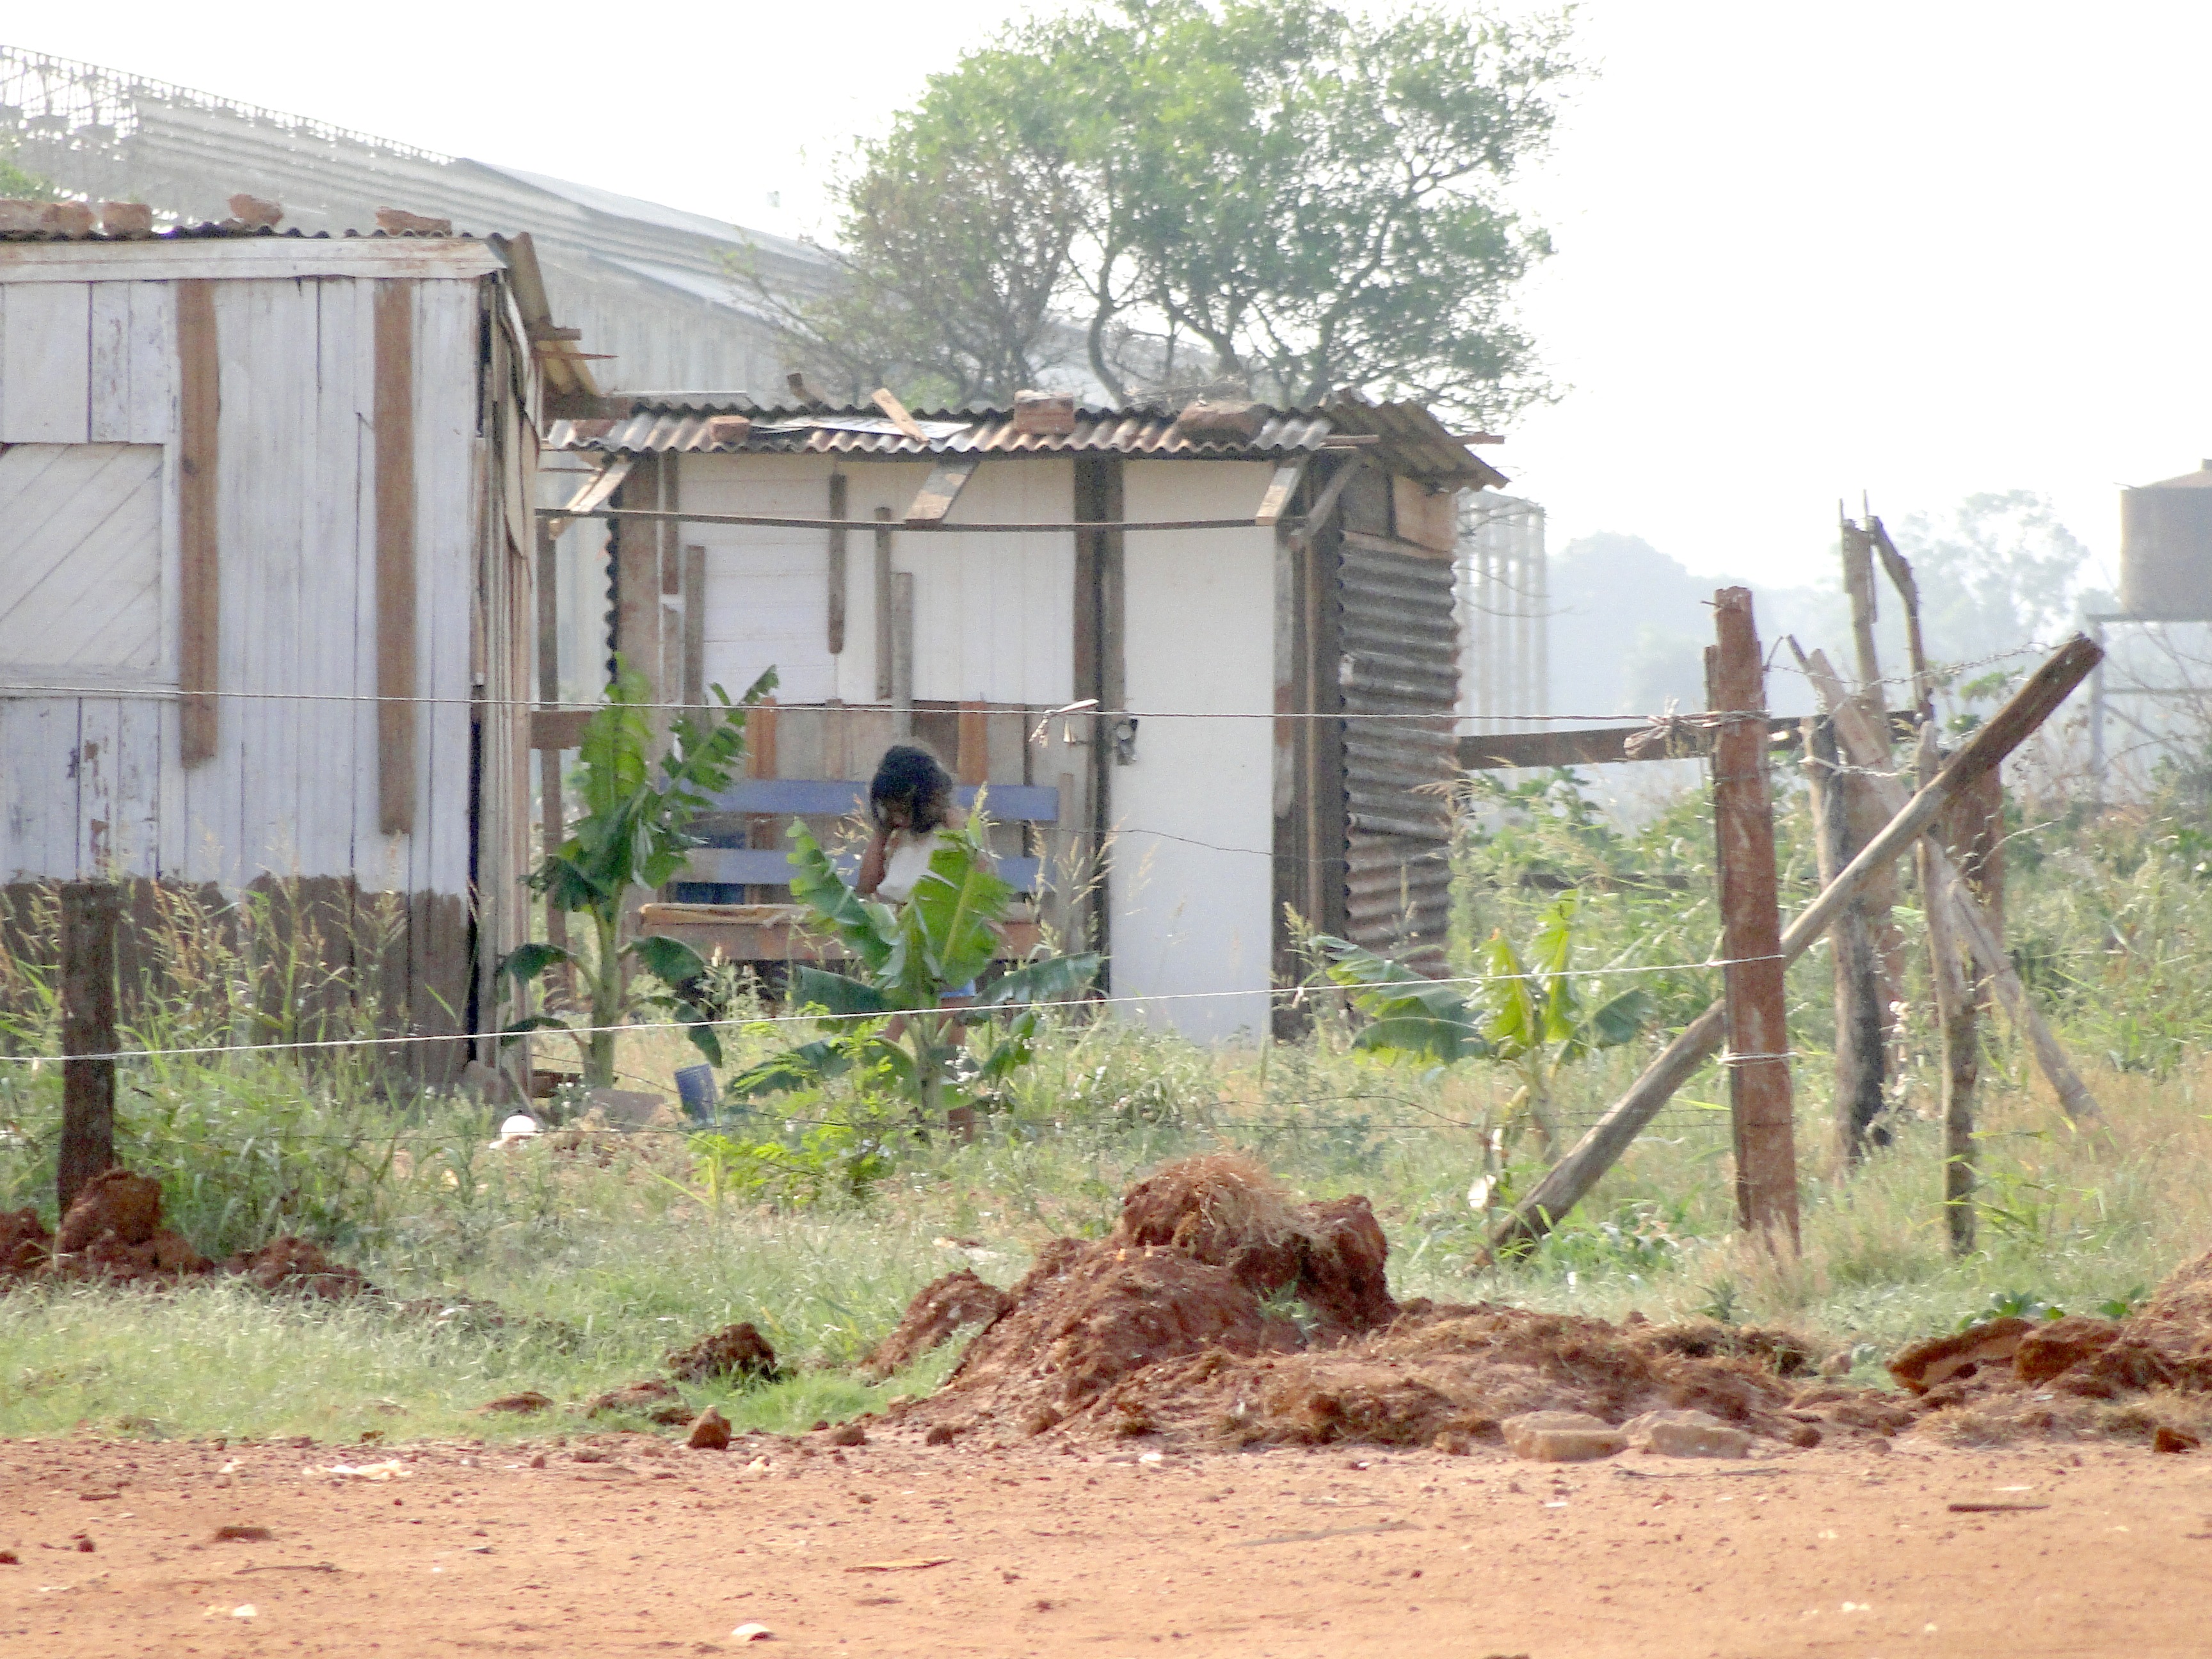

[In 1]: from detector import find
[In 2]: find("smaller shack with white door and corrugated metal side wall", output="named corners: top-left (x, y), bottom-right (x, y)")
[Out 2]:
top-left (549, 396), bottom-right (1504, 1038)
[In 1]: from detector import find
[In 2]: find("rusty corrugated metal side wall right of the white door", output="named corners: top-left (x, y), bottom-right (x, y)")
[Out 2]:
top-left (1338, 538), bottom-right (1460, 974)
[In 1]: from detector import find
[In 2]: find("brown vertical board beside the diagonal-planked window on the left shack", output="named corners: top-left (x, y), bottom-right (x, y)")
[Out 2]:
top-left (175, 278), bottom-right (223, 765)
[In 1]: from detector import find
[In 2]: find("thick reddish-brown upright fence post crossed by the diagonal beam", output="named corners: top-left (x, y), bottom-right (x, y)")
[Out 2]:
top-left (1708, 588), bottom-right (1799, 1250)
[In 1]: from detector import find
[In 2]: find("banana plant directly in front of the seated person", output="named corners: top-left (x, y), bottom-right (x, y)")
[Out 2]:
top-left (728, 816), bottom-right (1100, 1119)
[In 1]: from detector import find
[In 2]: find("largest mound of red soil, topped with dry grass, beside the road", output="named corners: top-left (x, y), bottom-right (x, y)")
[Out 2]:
top-left (902, 1157), bottom-right (1858, 1451)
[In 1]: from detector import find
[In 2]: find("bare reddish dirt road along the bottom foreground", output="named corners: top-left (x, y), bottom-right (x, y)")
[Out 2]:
top-left (0, 1436), bottom-right (2212, 1659)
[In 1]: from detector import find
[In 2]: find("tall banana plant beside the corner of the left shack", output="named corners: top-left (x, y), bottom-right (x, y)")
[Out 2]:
top-left (500, 659), bottom-right (776, 1088)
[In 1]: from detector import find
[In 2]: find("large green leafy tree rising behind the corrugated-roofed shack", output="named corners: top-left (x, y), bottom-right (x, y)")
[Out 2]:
top-left (752, 0), bottom-right (1573, 418)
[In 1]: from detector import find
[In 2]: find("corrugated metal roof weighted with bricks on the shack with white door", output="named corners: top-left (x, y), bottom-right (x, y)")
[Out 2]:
top-left (549, 398), bottom-right (1504, 489)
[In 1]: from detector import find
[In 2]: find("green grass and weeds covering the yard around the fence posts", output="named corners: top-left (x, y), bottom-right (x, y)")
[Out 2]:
top-left (0, 781), bottom-right (2212, 1438)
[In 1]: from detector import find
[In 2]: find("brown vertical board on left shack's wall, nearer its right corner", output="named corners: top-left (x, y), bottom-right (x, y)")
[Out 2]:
top-left (374, 278), bottom-right (421, 836)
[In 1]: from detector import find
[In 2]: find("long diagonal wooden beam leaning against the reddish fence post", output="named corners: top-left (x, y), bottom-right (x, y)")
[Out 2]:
top-left (1491, 635), bottom-right (2104, 1250)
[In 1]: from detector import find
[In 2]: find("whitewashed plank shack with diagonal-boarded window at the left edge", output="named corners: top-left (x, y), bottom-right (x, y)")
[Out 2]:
top-left (0, 210), bottom-right (591, 1075)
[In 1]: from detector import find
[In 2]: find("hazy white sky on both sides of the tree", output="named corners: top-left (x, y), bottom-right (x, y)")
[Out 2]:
top-left (21, 0), bottom-right (2212, 584)
